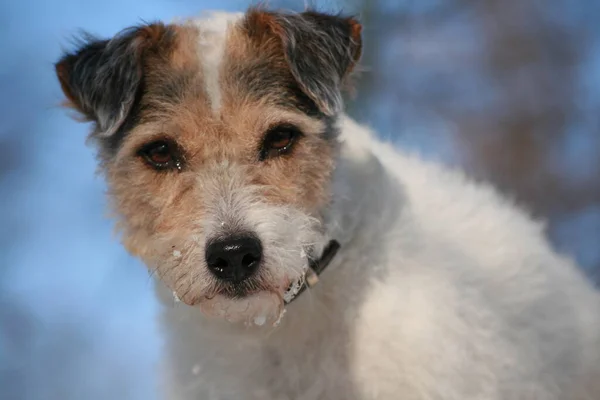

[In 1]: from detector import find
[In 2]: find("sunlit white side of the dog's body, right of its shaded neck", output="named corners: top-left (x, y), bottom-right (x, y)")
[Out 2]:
top-left (343, 114), bottom-right (600, 398)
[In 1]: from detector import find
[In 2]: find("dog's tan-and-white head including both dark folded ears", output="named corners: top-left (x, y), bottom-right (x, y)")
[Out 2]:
top-left (56, 10), bottom-right (361, 324)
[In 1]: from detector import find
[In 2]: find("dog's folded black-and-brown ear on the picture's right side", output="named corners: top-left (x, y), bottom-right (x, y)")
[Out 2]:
top-left (246, 9), bottom-right (362, 116)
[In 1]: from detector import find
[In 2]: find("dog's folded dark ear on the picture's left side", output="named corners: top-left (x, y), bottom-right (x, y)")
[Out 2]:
top-left (55, 23), bottom-right (172, 137)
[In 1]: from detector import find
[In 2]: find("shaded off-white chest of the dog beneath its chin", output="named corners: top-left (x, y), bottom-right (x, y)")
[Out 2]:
top-left (163, 296), bottom-right (356, 400)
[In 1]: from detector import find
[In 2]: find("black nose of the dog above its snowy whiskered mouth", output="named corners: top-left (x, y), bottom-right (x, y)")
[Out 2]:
top-left (206, 235), bottom-right (262, 283)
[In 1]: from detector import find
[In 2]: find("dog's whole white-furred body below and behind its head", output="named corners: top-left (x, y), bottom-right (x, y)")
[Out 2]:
top-left (155, 117), bottom-right (600, 400)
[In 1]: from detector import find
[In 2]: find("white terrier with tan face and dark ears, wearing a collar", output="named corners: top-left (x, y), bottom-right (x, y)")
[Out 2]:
top-left (55, 8), bottom-right (600, 400)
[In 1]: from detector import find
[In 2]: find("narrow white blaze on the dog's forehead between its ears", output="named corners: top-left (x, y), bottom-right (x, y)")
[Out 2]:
top-left (194, 11), bottom-right (244, 113)
